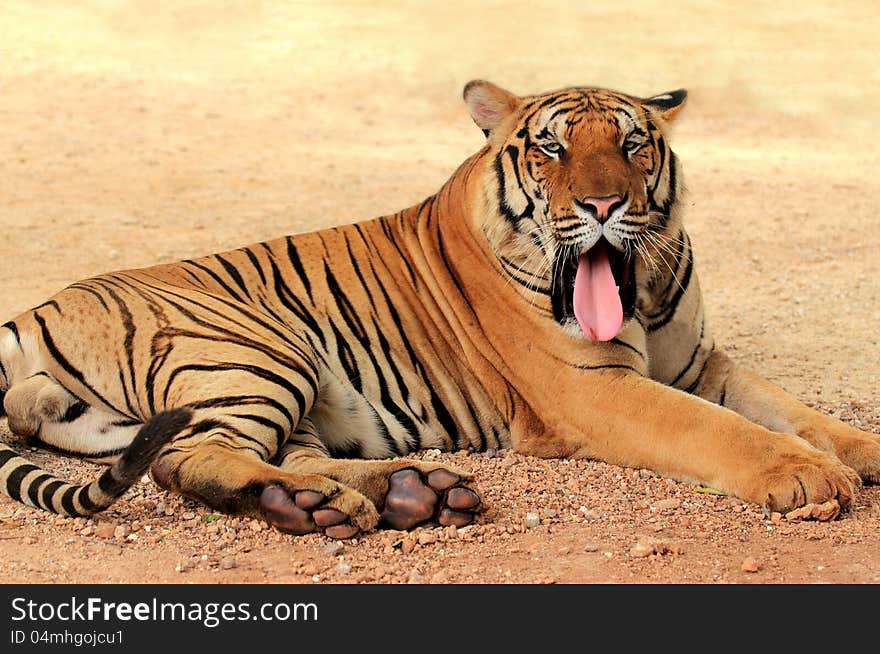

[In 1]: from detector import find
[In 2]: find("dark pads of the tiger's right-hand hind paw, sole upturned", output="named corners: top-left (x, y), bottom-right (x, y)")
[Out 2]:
top-left (382, 468), bottom-right (481, 529)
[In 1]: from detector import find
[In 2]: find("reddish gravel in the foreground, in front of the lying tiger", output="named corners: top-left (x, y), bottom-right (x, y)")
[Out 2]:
top-left (0, 400), bottom-right (880, 583)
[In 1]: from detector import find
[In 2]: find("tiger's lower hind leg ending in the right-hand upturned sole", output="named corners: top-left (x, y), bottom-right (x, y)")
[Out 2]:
top-left (277, 417), bottom-right (481, 529)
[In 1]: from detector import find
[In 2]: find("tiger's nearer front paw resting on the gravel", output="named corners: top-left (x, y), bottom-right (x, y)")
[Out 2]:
top-left (741, 446), bottom-right (861, 513)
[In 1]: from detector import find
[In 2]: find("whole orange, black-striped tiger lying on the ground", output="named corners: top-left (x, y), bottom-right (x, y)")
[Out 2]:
top-left (0, 80), bottom-right (880, 538)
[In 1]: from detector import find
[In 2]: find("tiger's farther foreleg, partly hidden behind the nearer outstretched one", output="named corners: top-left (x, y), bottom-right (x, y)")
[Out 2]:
top-left (694, 350), bottom-right (880, 483)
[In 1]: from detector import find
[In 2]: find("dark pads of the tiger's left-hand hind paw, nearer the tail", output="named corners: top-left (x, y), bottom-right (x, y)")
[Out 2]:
top-left (260, 484), bottom-right (361, 538)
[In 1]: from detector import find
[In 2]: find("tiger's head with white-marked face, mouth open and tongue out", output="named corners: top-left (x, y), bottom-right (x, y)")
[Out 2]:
top-left (464, 80), bottom-right (687, 341)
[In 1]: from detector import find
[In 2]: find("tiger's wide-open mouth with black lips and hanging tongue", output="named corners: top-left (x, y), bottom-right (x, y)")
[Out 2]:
top-left (552, 237), bottom-right (636, 341)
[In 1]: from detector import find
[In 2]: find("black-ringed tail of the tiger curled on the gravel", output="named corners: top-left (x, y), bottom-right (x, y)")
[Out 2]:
top-left (0, 408), bottom-right (192, 517)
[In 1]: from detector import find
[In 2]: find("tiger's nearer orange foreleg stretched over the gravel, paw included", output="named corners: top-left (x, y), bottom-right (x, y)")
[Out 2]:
top-left (511, 368), bottom-right (859, 511)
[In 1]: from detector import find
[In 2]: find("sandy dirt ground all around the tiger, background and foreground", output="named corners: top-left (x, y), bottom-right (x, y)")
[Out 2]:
top-left (0, 0), bottom-right (880, 583)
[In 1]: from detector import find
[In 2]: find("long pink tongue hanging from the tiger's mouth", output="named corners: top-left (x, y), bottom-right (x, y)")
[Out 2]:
top-left (574, 243), bottom-right (623, 341)
